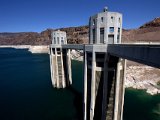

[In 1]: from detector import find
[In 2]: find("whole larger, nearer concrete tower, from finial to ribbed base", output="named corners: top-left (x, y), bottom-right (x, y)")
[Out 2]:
top-left (84, 7), bottom-right (123, 120)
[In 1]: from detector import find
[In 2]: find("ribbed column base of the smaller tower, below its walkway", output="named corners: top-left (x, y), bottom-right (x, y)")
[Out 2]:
top-left (50, 46), bottom-right (72, 88)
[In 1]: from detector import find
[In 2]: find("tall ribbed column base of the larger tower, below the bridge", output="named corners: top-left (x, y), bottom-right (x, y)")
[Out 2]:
top-left (83, 46), bottom-right (125, 120)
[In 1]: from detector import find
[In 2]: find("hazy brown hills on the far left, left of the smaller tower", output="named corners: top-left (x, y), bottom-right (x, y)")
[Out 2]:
top-left (0, 32), bottom-right (51, 45)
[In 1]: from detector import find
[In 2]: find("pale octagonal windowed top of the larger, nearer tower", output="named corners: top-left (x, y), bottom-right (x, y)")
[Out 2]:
top-left (89, 7), bottom-right (122, 44)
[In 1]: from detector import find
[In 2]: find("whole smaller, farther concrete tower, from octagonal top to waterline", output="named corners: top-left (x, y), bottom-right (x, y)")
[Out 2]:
top-left (50, 30), bottom-right (72, 88)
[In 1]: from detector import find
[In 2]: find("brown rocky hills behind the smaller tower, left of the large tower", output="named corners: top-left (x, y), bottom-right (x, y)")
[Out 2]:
top-left (0, 26), bottom-right (88, 45)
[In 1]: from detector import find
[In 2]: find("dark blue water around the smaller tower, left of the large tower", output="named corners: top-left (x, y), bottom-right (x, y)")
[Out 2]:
top-left (0, 49), bottom-right (82, 120)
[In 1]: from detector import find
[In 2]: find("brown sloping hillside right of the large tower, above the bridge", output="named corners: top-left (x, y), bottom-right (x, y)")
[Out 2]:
top-left (122, 18), bottom-right (160, 43)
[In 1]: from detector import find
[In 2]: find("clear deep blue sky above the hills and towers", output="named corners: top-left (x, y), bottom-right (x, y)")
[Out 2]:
top-left (0, 0), bottom-right (160, 32)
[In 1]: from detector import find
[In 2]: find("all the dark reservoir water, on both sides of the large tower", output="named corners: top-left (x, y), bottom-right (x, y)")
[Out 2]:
top-left (0, 48), bottom-right (160, 120)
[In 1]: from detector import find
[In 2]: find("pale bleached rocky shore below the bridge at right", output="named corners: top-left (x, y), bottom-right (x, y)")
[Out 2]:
top-left (125, 65), bottom-right (160, 95)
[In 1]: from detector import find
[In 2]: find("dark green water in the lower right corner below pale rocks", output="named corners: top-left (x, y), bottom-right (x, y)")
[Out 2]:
top-left (123, 89), bottom-right (160, 120)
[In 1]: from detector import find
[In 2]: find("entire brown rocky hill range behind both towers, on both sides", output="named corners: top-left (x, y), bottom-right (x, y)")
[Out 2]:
top-left (0, 18), bottom-right (160, 45)
